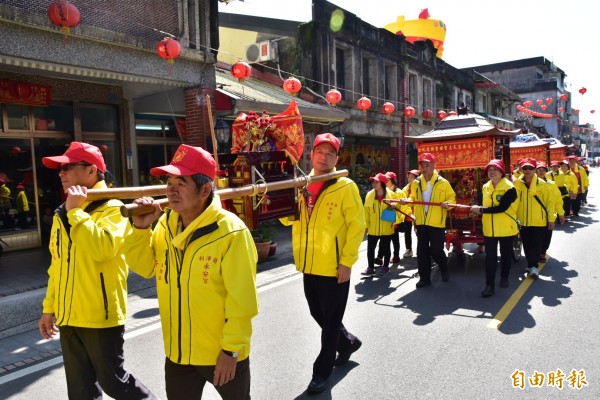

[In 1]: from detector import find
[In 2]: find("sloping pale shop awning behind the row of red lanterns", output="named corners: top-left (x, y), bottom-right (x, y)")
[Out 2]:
top-left (215, 68), bottom-right (350, 122)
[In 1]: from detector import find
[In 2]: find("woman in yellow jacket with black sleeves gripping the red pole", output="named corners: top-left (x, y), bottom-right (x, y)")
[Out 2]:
top-left (471, 160), bottom-right (519, 297)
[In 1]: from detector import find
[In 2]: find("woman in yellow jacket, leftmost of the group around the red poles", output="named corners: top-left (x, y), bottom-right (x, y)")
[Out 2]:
top-left (362, 173), bottom-right (401, 275)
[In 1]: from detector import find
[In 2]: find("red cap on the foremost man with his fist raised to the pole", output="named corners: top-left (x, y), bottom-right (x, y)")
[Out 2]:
top-left (150, 144), bottom-right (217, 180)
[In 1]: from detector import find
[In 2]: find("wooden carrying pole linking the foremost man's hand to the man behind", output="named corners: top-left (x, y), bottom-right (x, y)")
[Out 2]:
top-left (119, 169), bottom-right (348, 218)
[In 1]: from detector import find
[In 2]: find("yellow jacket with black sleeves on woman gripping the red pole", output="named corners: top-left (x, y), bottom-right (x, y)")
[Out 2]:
top-left (481, 178), bottom-right (519, 237)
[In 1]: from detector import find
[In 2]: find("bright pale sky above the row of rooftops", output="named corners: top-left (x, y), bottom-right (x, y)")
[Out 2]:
top-left (219, 0), bottom-right (600, 123)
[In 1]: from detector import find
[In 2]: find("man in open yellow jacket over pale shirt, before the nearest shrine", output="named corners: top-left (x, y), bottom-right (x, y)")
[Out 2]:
top-left (410, 153), bottom-right (456, 288)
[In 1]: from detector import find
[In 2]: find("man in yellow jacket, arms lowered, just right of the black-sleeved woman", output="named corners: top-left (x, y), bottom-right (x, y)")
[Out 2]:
top-left (514, 158), bottom-right (556, 279)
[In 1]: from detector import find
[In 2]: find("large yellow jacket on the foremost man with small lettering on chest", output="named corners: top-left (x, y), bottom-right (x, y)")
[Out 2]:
top-left (126, 195), bottom-right (258, 365)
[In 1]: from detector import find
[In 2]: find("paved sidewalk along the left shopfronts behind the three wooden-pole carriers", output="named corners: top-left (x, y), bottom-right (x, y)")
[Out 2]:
top-left (0, 226), bottom-right (295, 376)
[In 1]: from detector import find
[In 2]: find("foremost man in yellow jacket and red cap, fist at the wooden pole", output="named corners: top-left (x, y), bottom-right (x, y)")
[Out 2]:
top-left (126, 144), bottom-right (258, 400)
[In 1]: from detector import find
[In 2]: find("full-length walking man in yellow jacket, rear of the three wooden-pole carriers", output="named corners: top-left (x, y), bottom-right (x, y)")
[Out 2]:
top-left (281, 133), bottom-right (365, 394)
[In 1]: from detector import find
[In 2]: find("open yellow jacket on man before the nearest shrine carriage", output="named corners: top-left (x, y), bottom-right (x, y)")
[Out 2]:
top-left (410, 171), bottom-right (456, 228)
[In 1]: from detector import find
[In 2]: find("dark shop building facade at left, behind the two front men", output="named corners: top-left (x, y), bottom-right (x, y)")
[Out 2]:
top-left (0, 0), bottom-right (218, 251)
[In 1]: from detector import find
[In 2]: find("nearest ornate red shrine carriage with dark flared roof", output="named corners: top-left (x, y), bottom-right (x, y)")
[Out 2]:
top-left (405, 113), bottom-right (521, 260)
